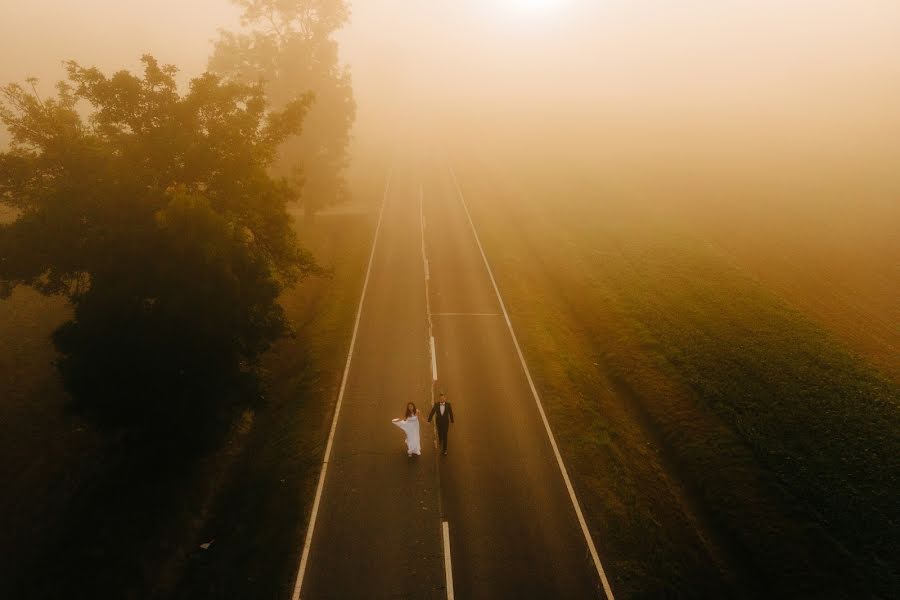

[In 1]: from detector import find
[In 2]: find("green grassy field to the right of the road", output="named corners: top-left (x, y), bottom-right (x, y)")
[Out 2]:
top-left (457, 161), bottom-right (900, 598)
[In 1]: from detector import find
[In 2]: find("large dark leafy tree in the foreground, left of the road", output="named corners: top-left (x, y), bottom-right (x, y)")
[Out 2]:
top-left (0, 56), bottom-right (316, 417)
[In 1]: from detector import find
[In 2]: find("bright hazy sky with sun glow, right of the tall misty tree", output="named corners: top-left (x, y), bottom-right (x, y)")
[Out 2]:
top-left (345, 0), bottom-right (900, 155)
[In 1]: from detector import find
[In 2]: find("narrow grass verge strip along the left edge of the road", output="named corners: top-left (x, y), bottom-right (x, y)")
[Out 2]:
top-left (171, 200), bottom-right (379, 598)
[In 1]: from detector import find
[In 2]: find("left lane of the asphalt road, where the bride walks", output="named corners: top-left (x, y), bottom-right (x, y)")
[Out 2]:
top-left (294, 172), bottom-right (446, 599)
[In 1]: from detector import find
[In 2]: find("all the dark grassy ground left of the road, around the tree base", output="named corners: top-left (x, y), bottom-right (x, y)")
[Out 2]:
top-left (0, 175), bottom-right (383, 598)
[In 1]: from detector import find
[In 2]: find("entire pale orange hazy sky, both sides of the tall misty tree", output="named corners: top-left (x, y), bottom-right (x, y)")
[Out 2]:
top-left (0, 0), bottom-right (900, 164)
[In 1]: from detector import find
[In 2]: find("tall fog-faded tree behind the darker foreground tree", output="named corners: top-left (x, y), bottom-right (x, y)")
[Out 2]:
top-left (209, 0), bottom-right (356, 214)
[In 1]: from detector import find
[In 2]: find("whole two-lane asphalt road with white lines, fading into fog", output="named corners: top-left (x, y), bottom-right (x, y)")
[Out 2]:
top-left (294, 164), bottom-right (611, 599)
